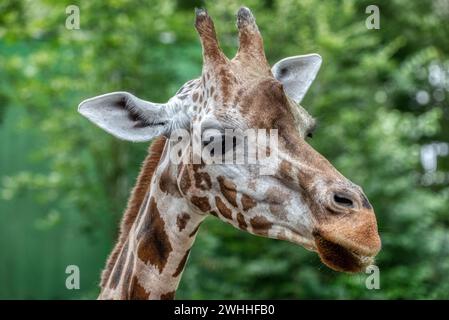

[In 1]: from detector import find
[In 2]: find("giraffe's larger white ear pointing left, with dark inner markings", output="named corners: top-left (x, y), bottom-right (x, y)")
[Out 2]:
top-left (78, 92), bottom-right (170, 142)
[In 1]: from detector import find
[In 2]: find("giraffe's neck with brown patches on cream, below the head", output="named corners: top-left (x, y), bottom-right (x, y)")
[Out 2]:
top-left (99, 143), bottom-right (205, 299)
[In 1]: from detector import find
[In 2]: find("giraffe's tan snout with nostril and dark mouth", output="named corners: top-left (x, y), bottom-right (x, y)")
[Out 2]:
top-left (313, 184), bottom-right (381, 272)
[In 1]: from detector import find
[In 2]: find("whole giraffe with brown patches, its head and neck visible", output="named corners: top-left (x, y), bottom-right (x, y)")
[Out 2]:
top-left (78, 7), bottom-right (381, 300)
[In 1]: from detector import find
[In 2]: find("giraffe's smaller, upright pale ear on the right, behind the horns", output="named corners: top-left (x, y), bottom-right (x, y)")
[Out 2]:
top-left (271, 53), bottom-right (322, 103)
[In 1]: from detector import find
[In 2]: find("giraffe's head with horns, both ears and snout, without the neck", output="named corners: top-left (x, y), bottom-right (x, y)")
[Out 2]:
top-left (79, 8), bottom-right (381, 272)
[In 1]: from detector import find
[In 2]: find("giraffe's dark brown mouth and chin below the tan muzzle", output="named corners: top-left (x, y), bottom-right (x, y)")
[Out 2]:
top-left (314, 233), bottom-right (374, 273)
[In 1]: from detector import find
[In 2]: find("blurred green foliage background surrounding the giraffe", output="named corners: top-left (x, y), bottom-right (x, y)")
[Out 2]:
top-left (0, 0), bottom-right (449, 299)
